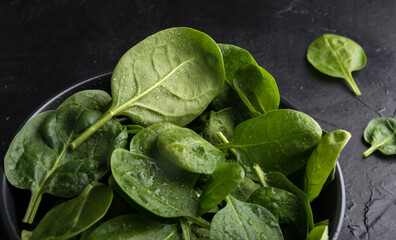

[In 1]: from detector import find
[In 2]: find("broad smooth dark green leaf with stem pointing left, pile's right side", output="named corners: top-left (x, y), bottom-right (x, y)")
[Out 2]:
top-left (217, 109), bottom-right (322, 180)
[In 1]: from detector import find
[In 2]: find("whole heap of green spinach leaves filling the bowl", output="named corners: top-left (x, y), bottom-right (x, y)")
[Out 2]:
top-left (4, 27), bottom-right (350, 240)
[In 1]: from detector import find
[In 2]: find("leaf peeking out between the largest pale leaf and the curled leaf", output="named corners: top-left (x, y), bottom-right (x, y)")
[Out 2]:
top-left (217, 43), bottom-right (257, 86)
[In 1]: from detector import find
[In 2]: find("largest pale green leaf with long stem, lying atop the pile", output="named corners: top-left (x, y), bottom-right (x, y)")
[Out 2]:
top-left (72, 27), bottom-right (225, 148)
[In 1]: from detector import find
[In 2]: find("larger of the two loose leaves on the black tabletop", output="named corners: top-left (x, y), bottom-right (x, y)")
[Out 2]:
top-left (307, 34), bottom-right (367, 95)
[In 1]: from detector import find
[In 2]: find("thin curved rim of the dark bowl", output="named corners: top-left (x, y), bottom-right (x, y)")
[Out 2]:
top-left (0, 72), bottom-right (346, 240)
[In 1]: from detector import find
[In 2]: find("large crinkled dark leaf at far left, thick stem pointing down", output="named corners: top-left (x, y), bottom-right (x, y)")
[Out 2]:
top-left (4, 104), bottom-right (125, 223)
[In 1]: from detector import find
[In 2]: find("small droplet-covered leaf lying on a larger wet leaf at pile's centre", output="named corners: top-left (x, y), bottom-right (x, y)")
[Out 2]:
top-left (157, 127), bottom-right (225, 174)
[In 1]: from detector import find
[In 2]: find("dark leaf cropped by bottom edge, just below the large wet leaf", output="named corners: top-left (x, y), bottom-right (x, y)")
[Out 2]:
top-left (87, 214), bottom-right (182, 240)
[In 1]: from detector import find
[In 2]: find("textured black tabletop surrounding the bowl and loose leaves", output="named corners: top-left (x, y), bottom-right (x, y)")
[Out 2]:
top-left (0, 0), bottom-right (396, 239)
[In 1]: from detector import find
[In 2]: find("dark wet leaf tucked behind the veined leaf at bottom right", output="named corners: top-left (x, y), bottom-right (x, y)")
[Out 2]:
top-left (248, 187), bottom-right (307, 239)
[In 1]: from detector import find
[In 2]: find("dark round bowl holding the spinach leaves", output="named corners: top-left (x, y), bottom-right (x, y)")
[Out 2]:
top-left (0, 73), bottom-right (345, 240)
